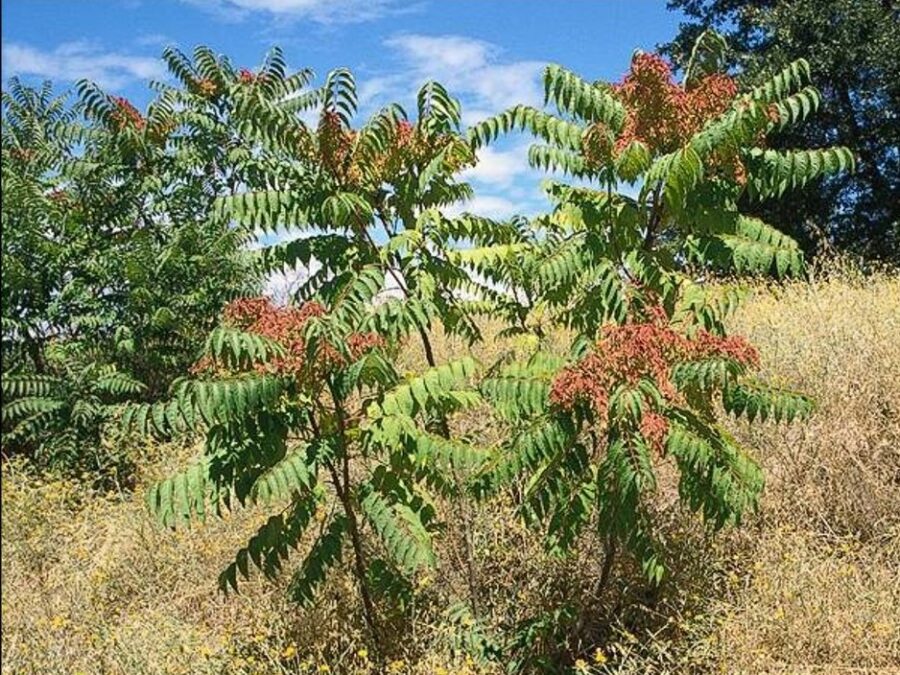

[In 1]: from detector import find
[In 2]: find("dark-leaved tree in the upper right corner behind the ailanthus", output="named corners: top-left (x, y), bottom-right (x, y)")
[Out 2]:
top-left (665, 0), bottom-right (900, 261)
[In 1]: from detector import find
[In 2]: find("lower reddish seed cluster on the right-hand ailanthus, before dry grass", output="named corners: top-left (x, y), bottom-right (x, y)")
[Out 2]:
top-left (550, 308), bottom-right (759, 448)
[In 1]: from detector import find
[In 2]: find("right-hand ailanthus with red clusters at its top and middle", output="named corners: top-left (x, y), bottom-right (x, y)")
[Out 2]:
top-left (469, 33), bottom-right (853, 656)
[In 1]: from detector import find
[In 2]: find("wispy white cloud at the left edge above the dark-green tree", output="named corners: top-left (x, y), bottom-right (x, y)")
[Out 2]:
top-left (2, 41), bottom-right (166, 89)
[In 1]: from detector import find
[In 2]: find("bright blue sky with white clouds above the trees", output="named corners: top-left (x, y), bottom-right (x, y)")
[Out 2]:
top-left (2, 0), bottom-right (680, 217)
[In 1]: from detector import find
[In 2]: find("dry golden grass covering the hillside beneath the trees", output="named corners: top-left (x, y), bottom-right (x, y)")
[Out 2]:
top-left (2, 272), bottom-right (900, 673)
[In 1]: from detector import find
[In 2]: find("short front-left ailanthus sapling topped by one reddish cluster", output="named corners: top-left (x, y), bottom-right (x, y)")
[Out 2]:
top-left (123, 282), bottom-right (484, 644)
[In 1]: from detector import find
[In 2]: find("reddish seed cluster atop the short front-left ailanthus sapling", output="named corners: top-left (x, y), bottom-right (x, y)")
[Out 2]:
top-left (192, 297), bottom-right (383, 377)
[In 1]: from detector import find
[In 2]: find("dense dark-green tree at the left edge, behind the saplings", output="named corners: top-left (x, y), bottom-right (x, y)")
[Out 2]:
top-left (2, 59), bottom-right (268, 463)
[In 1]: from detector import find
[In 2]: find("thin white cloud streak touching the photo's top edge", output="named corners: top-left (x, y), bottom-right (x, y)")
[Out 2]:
top-left (182, 0), bottom-right (408, 24)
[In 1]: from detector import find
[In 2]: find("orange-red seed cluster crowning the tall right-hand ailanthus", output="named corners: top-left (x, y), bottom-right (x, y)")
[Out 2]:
top-left (613, 54), bottom-right (737, 153)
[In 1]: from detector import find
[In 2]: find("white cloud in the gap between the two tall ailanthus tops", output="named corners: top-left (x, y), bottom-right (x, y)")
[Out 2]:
top-left (360, 34), bottom-right (544, 123)
